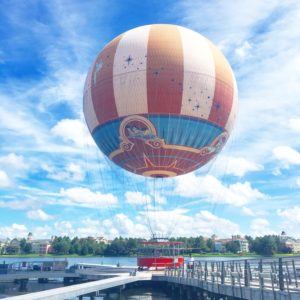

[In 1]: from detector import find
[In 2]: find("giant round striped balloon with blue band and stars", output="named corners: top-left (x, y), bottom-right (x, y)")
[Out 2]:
top-left (83, 24), bottom-right (237, 177)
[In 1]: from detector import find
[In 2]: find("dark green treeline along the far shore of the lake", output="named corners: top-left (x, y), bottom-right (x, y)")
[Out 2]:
top-left (6, 235), bottom-right (292, 256)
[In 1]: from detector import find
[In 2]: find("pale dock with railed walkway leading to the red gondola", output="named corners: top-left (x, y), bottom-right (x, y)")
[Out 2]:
top-left (1, 257), bottom-right (300, 300)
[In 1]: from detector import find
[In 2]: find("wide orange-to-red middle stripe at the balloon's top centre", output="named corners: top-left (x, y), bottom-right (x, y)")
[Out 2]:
top-left (147, 25), bottom-right (184, 114)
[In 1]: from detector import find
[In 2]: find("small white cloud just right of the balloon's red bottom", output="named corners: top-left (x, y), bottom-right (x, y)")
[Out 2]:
top-left (225, 157), bottom-right (264, 177)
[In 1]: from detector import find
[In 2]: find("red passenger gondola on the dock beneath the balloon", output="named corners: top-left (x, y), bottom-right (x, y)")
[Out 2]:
top-left (137, 240), bottom-right (184, 270)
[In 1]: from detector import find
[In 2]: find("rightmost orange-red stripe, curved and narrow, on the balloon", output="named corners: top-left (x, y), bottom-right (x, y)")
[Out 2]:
top-left (208, 41), bottom-right (234, 127)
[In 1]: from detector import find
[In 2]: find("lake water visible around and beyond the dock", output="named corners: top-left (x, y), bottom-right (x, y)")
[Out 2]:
top-left (0, 256), bottom-right (250, 300)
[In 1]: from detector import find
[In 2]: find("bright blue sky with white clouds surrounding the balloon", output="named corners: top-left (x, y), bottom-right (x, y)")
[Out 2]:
top-left (0, 0), bottom-right (300, 239)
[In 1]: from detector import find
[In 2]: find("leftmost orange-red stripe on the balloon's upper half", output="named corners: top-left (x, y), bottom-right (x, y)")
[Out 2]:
top-left (92, 35), bottom-right (123, 125)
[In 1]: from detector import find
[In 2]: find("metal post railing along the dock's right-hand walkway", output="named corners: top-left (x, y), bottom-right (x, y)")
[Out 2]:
top-left (165, 257), bottom-right (300, 292)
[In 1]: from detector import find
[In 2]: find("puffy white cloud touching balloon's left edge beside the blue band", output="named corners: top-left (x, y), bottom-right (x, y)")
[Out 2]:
top-left (51, 119), bottom-right (95, 148)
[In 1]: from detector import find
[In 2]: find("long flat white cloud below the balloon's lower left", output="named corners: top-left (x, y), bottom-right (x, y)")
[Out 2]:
top-left (58, 187), bottom-right (118, 210)
